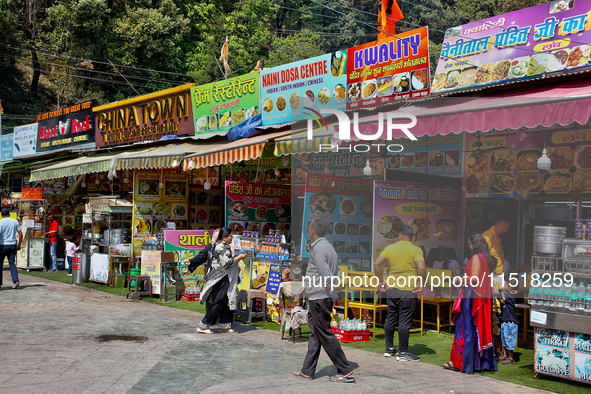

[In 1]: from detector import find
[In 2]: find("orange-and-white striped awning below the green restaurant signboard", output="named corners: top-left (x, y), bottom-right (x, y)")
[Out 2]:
top-left (183, 131), bottom-right (291, 171)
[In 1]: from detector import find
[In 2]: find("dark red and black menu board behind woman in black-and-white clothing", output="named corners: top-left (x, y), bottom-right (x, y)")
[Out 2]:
top-left (226, 181), bottom-right (291, 242)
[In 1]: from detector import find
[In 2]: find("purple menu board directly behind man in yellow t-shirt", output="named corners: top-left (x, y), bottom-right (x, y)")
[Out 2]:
top-left (372, 181), bottom-right (462, 261)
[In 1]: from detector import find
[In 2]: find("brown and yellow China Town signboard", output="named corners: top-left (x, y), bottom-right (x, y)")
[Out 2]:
top-left (94, 84), bottom-right (195, 148)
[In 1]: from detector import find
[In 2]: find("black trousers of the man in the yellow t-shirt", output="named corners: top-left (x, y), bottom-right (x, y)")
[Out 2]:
top-left (384, 289), bottom-right (417, 352)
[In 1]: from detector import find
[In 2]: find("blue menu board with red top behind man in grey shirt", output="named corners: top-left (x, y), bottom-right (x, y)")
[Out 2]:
top-left (301, 175), bottom-right (373, 268)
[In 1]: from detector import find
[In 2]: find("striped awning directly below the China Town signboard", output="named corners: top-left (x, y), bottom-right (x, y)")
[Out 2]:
top-left (115, 142), bottom-right (224, 170)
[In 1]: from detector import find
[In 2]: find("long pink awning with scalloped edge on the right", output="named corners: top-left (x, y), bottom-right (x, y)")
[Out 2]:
top-left (351, 80), bottom-right (591, 139)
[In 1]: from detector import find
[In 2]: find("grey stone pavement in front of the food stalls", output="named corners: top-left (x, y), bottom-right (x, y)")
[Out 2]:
top-left (0, 275), bottom-right (544, 394)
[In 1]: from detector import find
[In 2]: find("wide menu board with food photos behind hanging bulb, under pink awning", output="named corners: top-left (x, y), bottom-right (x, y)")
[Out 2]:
top-left (464, 129), bottom-right (591, 197)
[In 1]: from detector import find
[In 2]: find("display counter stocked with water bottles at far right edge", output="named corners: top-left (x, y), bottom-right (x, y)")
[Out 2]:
top-left (528, 239), bottom-right (591, 383)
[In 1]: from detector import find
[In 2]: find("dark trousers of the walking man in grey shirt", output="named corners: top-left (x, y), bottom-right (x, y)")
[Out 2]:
top-left (302, 298), bottom-right (353, 377)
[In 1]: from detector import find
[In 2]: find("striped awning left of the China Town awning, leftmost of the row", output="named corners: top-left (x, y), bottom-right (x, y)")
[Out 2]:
top-left (30, 153), bottom-right (116, 182)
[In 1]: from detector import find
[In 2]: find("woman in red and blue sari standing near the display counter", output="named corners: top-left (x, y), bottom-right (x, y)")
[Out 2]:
top-left (443, 234), bottom-right (497, 374)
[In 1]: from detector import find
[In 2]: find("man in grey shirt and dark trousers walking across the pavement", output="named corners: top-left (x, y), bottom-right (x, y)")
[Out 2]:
top-left (294, 219), bottom-right (355, 383)
